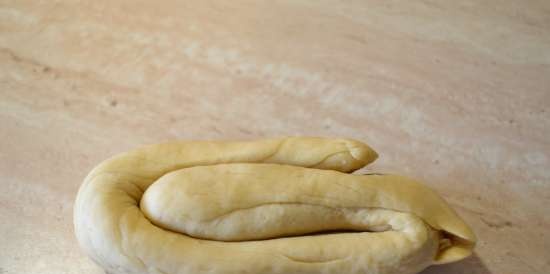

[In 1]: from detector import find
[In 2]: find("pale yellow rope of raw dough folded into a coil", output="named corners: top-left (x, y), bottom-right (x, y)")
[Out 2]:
top-left (74, 137), bottom-right (475, 274)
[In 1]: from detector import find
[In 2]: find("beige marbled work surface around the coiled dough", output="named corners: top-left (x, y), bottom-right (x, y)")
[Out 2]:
top-left (0, 0), bottom-right (550, 274)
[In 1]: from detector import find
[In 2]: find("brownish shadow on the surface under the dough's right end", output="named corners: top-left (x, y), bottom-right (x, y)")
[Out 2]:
top-left (419, 253), bottom-right (493, 274)
